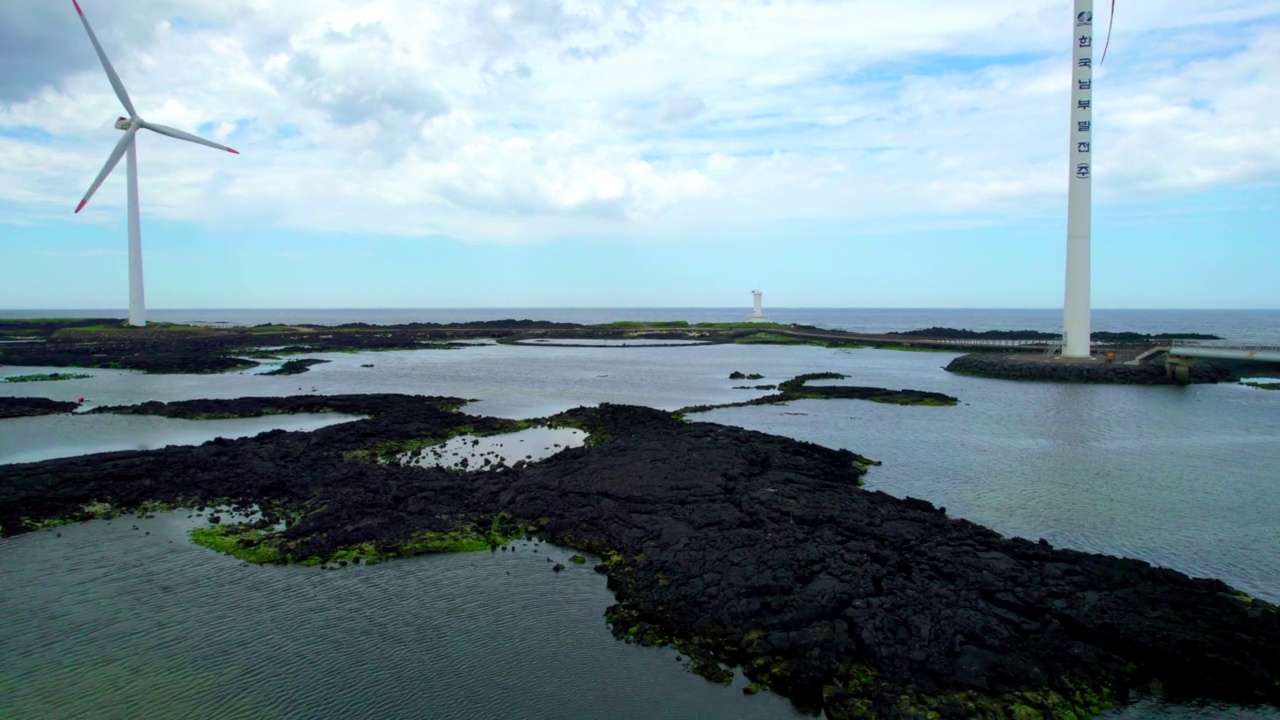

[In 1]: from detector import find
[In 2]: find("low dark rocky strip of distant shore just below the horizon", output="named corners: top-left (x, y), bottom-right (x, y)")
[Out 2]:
top-left (0, 318), bottom-right (1239, 373)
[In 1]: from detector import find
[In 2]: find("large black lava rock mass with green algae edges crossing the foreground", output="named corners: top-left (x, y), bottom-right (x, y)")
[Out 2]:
top-left (0, 395), bottom-right (1280, 720)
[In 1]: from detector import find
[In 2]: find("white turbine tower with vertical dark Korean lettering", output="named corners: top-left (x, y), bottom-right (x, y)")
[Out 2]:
top-left (1062, 0), bottom-right (1093, 357)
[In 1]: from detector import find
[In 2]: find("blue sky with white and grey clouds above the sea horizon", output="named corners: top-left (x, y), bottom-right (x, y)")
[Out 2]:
top-left (0, 0), bottom-right (1280, 309)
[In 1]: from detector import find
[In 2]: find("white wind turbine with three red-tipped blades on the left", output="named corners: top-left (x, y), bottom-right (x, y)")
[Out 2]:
top-left (72, 0), bottom-right (239, 327)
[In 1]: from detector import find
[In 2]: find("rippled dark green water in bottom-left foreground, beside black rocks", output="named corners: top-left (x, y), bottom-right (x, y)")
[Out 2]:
top-left (0, 514), bottom-right (795, 720)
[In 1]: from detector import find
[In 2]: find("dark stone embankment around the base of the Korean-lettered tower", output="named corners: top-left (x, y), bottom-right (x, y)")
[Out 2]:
top-left (946, 354), bottom-right (1239, 386)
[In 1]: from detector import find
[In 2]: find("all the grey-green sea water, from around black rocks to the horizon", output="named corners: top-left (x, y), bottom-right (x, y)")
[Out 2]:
top-left (0, 307), bottom-right (1280, 720)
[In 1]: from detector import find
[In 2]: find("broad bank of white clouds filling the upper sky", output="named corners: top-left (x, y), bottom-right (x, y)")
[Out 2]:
top-left (0, 0), bottom-right (1280, 240)
